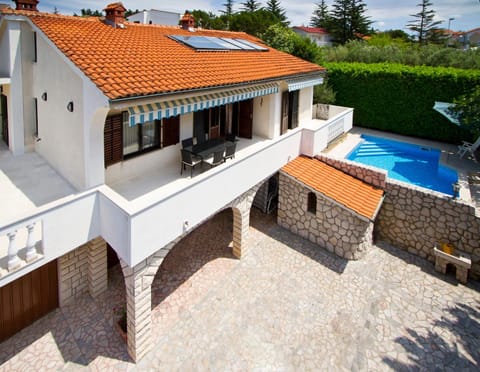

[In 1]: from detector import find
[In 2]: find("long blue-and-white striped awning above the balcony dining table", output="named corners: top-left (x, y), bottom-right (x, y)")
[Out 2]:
top-left (128, 83), bottom-right (278, 126)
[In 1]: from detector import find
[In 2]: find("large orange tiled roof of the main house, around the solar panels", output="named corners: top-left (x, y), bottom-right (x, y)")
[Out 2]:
top-left (3, 10), bottom-right (324, 99)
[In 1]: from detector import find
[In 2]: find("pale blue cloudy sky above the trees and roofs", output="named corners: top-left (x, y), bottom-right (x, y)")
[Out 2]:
top-left (36, 0), bottom-right (480, 33)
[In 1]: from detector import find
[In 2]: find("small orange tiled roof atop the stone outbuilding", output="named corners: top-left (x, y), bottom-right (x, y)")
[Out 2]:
top-left (282, 156), bottom-right (383, 219)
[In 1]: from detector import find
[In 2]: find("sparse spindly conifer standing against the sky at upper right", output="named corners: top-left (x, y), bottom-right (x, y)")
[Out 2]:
top-left (407, 0), bottom-right (442, 44)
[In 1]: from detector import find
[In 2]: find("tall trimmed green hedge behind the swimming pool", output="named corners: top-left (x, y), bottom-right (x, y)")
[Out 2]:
top-left (325, 62), bottom-right (480, 143)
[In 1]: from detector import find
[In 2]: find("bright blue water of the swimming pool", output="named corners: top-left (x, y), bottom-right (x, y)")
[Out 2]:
top-left (347, 135), bottom-right (458, 195)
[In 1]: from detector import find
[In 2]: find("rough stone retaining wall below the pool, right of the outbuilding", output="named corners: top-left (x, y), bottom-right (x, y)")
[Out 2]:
top-left (375, 181), bottom-right (480, 279)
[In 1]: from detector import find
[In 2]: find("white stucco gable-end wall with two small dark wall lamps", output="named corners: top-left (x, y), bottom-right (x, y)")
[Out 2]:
top-left (33, 29), bottom-right (85, 189)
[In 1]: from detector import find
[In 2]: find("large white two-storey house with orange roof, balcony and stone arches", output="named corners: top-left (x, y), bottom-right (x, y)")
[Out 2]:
top-left (0, 0), bottom-right (353, 360)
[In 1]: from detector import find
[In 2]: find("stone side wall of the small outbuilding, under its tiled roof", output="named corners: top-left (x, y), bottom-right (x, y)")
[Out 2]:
top-left (277, 172), bottom-right (373, 260)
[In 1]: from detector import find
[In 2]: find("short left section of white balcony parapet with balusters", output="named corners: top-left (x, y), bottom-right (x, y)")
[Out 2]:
top-left (0, 190), bottom-right (100, 286)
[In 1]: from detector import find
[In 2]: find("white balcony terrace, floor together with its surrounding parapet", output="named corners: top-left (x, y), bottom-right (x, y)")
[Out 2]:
top-left (0, 109), bottom-right (353, 283)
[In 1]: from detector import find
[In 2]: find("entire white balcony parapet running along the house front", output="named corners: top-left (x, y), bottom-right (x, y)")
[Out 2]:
top-left (0, 108), bottom-right (353, 286)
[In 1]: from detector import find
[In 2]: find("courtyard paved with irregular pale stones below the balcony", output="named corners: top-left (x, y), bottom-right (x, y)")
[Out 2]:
top-left (0, 209), bottom-right (480, 371)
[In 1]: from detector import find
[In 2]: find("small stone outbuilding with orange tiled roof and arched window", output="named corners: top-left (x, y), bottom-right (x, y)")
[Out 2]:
top-left (277, 156), bottom-right (384, 260)
